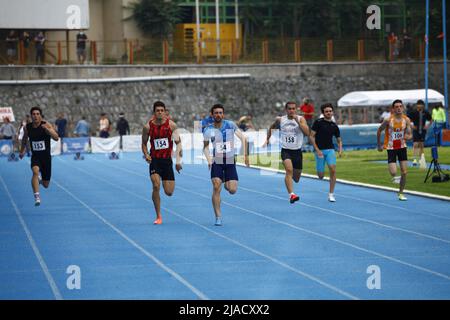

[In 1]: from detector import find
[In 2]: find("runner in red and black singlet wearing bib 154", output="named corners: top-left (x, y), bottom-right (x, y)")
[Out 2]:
top-left (142, 101), bottom-right (182, 224)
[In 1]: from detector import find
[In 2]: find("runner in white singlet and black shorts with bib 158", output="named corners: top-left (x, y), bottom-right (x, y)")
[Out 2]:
top-left (264, 102), bottom-right (309, 203)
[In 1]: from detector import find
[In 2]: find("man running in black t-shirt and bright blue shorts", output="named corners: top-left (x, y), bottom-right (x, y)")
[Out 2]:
top-left (310, 103), bottom-right (342, 202)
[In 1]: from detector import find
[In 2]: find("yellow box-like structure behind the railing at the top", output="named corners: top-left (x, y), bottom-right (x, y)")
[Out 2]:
top-left (174, 23), bottom-right (242, 56)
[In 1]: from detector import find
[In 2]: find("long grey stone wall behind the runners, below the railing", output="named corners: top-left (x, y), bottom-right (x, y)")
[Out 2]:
top-left (0, 63), bottom-right (444, 134)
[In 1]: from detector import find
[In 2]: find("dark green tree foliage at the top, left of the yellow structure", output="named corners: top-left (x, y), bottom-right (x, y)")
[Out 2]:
top-left (127, 0), bottom-right (181, 39)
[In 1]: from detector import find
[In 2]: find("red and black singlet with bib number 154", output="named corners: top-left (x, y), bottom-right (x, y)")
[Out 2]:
top-left (148, 119), bottom-right (173, 159)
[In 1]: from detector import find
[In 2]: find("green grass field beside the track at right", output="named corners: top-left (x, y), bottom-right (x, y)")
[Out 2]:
top-left (238, 147), bottom-right (450, 197)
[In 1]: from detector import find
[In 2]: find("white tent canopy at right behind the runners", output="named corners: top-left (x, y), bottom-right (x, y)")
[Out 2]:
top-left (337, 89), bottom-right (445, 108)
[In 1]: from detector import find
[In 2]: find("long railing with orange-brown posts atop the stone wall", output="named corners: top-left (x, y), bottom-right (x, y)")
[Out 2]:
top-left (0, 38), bottom-right (442, 65)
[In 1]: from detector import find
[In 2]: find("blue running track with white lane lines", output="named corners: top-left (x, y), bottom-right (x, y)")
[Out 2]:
top-left (0, 153), bottom-right (450, 300)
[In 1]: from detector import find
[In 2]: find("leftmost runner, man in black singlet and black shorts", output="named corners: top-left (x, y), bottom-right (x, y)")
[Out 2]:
top-left (19, 107), bottom-right (59, 206)
